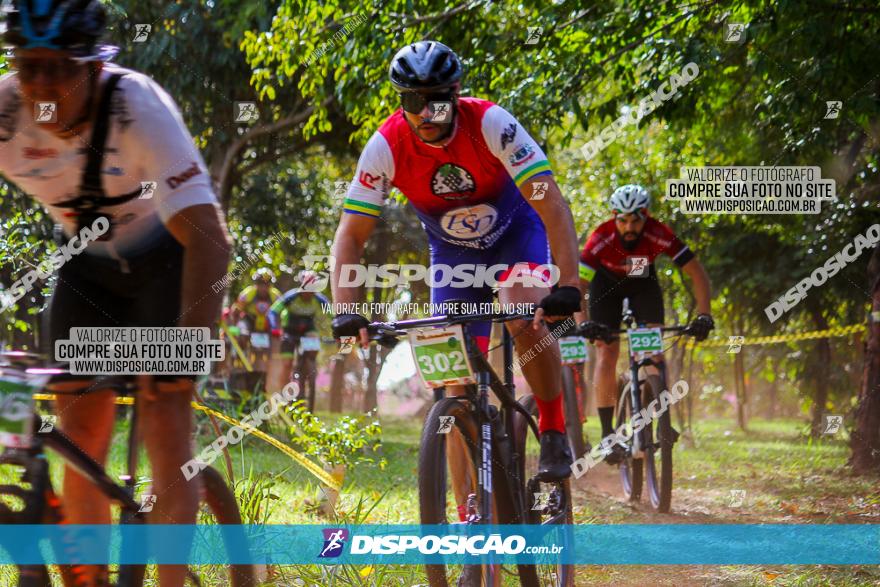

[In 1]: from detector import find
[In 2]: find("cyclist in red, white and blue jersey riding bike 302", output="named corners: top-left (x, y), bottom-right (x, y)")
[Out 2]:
top-left (332, 41), bottom-right (581, 480)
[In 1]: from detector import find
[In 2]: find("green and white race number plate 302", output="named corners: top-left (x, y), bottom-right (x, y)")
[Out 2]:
top-left (409, 324), bottom-right (476, 387)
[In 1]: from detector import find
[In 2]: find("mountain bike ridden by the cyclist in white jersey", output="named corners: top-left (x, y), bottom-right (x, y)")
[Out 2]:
top-left (0, 351), bottom-right (255, 587)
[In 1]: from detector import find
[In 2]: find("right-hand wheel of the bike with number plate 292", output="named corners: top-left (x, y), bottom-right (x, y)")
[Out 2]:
top-left (642, 375), bottom-right (674, 514)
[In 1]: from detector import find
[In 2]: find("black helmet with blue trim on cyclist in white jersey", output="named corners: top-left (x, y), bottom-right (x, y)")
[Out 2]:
top-left (3, 0), bottom-right (117, 60)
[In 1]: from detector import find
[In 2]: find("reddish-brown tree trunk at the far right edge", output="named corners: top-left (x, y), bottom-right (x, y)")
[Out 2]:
top-left (849, 247), bottom-right (880, 475)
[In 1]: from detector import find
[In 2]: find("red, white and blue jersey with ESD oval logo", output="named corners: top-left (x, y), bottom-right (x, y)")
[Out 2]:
top-left (344, 98), bottom-right (551, 249)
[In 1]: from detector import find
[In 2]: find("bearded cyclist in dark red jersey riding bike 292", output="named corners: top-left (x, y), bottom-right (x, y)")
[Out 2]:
top-left (575, 185), bottom-right (715, 465)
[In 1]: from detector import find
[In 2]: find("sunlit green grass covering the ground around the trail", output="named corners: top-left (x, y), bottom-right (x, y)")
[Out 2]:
top-left (0, 406), bottom-right (880, 587)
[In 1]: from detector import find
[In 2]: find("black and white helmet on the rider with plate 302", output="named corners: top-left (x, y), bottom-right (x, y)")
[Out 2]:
top-left (388, 41), bottom-right (462, 92)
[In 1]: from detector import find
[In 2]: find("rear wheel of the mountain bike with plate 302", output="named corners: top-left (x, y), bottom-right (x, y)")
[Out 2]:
top-left (511, 396), bottom-right (579, 587)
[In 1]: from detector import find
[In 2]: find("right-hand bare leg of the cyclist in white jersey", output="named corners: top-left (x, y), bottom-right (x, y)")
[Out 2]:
top-left (138, 379), bottom-right (200, 587)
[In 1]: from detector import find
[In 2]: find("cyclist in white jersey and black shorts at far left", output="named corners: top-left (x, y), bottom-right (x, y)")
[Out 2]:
top-left (0, 0), bottom-right (230, 586)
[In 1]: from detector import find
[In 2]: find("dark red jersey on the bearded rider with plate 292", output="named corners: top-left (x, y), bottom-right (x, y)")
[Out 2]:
top-left (580, 216), bottom-right (694, 281)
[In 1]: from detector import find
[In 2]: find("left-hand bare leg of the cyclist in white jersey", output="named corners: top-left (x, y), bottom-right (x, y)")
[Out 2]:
top-left (48, 381), bottom-right (116, 585)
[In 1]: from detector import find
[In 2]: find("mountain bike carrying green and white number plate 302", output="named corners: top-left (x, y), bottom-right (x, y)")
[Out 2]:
top-left (368, 314), bottom-right (574, 587)
